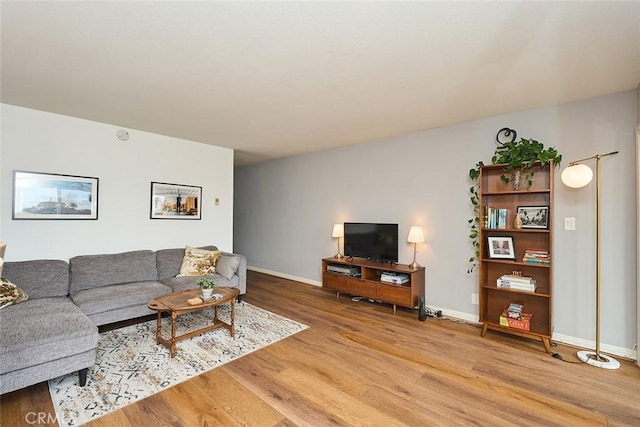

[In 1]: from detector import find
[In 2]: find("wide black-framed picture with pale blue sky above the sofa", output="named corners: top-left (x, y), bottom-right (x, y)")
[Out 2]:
top-left (11, 171), bottom-right (98, 219)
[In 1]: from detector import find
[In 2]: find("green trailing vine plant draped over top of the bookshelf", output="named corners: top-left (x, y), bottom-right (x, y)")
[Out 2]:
top-left (467, 128), bottom-right (562, 273)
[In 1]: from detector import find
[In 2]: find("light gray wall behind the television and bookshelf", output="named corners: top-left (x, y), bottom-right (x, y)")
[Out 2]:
top-left (234, 91), bottom-right (637, 354)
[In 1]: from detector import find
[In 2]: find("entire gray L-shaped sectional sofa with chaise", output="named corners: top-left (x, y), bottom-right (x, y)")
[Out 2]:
top-left (0, 246), bottom-right (247, 394)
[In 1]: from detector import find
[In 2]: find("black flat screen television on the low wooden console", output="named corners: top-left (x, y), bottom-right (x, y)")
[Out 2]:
top-left (344, 222), bottom-right (398, 262)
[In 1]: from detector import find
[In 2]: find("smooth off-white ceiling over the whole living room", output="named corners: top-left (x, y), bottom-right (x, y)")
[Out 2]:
top-left (0, 0), bottom-right (640, 165)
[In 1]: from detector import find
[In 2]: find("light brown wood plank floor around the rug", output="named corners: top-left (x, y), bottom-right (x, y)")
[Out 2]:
top-left (0, 272), bottom-right (640, 427)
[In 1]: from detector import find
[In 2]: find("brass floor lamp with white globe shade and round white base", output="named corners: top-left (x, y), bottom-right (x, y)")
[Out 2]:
top-left (561, 151), bottom-right (620, 369)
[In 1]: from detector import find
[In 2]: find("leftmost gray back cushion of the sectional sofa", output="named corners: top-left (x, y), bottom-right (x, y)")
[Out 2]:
top-left (2, 260), bottom-right (69, 300)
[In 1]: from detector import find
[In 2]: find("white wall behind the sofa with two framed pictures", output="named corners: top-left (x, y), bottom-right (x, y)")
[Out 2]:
top-left (0, 104), bottom-right (233, 261)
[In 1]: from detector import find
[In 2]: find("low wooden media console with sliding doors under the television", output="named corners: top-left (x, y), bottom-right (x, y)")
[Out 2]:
top-left (322, 258), bottom-right (425, 314)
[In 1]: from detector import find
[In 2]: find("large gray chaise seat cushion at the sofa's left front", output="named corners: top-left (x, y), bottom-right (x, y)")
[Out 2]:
top-left (0, 297), bottom-right (98, 374)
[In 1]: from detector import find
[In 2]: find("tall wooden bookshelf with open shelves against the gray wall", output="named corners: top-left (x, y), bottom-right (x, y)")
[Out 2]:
top-left (478, 164), bottom-right (554, 353)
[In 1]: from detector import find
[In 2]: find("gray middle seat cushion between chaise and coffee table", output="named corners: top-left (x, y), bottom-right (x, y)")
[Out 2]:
top-left (71, 281), bottom-right (172, 316)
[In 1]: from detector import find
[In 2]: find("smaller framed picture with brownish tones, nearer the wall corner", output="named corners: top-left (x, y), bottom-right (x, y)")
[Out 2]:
top-left (150, 182), bottom-right (202, 220)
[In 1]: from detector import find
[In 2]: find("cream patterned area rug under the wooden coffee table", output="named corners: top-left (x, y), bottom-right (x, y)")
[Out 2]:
top-left (49, 302), bottom-right (307, 426)
